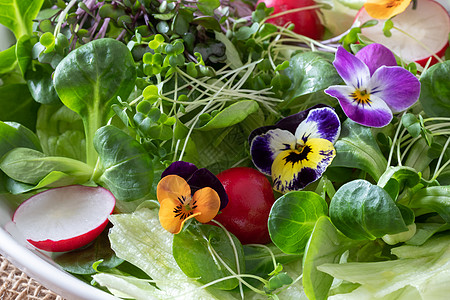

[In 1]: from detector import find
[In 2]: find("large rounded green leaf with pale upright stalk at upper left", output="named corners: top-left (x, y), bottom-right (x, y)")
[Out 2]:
top-left (53, 39), bottom-right (136, 166)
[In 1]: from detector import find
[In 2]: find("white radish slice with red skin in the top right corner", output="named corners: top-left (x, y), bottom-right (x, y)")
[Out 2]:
top-left (354, 0), bottom-right (450, 66)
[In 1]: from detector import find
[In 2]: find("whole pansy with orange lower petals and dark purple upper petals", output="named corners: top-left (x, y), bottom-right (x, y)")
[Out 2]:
top-left (156, 161), bottom-right (228, 234)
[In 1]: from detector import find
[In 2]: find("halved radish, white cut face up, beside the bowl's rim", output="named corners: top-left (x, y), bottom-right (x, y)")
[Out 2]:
top-left (13, 185), bottom-right (116, 252)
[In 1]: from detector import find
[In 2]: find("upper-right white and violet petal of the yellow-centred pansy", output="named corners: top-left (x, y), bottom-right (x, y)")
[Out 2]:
top-left (295, 107), bottom-right (341, 143)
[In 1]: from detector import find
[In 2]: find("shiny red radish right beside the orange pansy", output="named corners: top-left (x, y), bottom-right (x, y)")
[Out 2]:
top-left (214, 167), bottom-right (275, 244)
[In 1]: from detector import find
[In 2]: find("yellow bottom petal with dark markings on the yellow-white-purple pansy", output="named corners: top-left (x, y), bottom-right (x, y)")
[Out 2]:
top-left (272, 139), bottom-right (336, 193)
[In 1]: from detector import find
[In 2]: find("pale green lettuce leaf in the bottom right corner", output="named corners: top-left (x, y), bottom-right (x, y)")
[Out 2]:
top-left (318, 235), bottom-right (450, 300)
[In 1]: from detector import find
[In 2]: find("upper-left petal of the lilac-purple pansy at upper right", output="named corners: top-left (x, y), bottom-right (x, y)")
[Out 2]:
top-left (333, 46), bottom-right (370, 89)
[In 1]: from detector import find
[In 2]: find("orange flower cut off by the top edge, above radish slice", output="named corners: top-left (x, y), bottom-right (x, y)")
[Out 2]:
top-left (364, 0), bottom-right (411, 20)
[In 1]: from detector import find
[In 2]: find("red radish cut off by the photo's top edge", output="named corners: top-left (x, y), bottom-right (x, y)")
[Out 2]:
top-left (258, 0), bottom-right (325, 40)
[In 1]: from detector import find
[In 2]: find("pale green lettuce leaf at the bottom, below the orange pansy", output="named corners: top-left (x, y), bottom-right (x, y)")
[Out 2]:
top-left (102, 208), bottom-right (239, 300)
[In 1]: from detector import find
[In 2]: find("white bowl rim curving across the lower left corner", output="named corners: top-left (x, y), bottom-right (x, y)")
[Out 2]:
top-left (0, 196), bottom-right (117, 300)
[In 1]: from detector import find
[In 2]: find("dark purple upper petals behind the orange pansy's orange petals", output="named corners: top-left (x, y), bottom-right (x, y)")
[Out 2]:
top-left (161, 161), bottom-right (228, 210)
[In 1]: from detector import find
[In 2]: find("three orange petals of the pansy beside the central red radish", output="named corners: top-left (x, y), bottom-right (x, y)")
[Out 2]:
top-left (156, 175), bottom-right (220, 234)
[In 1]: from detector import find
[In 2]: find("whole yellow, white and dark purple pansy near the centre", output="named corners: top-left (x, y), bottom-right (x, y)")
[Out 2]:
top-left (249, 105), bottom-right (341, 193)
